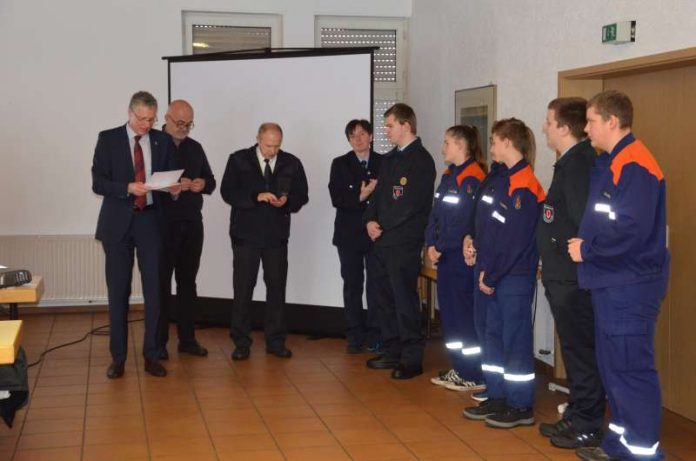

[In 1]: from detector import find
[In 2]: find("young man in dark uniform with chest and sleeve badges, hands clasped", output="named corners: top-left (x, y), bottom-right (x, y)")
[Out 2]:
top-left (363, 103), bottom-right (435, 379)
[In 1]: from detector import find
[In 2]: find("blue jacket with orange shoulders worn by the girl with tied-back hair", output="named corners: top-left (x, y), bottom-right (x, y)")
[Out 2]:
top-left (425, 159), bottom-right (485, 251)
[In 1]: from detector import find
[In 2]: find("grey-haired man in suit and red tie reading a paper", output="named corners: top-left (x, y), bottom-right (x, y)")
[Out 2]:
top-left (92, 91), bottom-right (179, 379)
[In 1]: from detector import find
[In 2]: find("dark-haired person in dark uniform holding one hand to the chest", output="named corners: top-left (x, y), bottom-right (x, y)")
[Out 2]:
top-left (329, 120), bottom-right (382, 354)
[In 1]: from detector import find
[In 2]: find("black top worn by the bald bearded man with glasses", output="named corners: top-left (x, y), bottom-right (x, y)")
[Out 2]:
top-left (162, 127), bottom-right (216, 221)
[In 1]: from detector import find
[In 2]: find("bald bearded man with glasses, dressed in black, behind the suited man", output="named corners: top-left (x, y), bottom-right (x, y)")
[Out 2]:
top-left (159, 99), bottom-right (215, 359)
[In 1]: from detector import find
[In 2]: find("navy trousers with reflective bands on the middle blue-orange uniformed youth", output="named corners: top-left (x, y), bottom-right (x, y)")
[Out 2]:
top-left (481, 273), bottom-right (536, 408)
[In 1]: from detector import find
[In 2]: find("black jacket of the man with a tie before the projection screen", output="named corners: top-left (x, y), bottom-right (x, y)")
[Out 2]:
top-left (220, 145), bottom-right (309, 247)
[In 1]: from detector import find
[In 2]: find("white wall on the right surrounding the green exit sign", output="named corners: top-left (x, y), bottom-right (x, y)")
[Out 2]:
top-left (408, 0), bottom-right (696, 187)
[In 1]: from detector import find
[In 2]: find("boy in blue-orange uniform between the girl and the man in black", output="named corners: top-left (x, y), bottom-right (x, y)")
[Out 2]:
top-left (464, 118), bottom-right (545, 428)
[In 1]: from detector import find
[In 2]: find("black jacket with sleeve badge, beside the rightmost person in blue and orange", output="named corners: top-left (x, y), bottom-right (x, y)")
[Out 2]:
top-left (537, 140), bottom-right (597, 281)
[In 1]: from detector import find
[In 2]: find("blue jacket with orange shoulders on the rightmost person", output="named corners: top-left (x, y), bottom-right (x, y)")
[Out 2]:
top-left (578, 134), bottom-right (669, 289)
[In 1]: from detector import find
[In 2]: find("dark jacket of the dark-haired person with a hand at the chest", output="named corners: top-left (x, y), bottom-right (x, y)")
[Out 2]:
top-left (329, 151), bottom-right (382, 251)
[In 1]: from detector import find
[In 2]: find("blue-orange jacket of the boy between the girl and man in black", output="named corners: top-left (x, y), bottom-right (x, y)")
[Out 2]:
top-left (476, 160), bottom-right (545, 287)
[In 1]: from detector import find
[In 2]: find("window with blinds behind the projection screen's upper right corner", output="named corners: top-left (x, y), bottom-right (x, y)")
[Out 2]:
top-left (315, 16), bottom-right (406, 153)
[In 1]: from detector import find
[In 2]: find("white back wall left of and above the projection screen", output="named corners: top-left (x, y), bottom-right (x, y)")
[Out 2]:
top-left (0, 0), bottom-right (411, 235)
